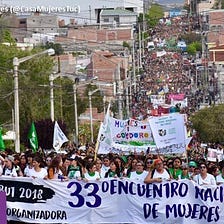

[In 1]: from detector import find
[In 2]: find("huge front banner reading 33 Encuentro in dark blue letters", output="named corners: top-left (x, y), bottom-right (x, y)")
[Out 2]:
top-left (0, 177), bottom-right (224, 224)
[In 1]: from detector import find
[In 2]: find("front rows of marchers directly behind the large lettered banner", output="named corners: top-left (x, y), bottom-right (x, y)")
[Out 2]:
top-left (0, 147), bottom-right (224, 187)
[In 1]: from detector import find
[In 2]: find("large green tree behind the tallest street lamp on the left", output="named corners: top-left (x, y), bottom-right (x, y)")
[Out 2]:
top-left (0, 45), bottom-right (53, 139)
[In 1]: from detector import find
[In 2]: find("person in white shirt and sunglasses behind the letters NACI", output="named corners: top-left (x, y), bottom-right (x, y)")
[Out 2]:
top-left (193, 163), bottom-right (217, 187)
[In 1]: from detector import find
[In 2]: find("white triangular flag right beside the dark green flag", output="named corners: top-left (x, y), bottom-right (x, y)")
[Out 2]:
top-left (53, 121), bottom-right (68, 151)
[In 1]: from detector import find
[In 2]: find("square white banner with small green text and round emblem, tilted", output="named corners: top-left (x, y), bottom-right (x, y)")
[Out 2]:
top-left (149, 113), bottom-right (186, 148)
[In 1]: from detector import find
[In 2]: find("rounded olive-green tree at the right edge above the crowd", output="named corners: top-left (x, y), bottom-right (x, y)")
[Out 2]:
top-left (191, 105), bottom-right (224, 143)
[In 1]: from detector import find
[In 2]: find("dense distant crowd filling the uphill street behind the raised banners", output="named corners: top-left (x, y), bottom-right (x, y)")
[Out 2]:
top-left (131, 14), bottom-right (209, 119)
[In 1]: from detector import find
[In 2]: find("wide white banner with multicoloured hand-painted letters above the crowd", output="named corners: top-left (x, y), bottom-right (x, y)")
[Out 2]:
top-left (98, 116), bottom-right (153, 154)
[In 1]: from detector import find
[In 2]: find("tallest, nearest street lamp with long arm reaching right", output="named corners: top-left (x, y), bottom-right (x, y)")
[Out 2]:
top-left (13, 49), bottom-right (55, 153)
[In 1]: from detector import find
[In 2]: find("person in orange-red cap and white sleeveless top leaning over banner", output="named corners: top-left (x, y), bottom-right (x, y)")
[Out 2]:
top-left (144, 159), bottom-right (172, 184)
